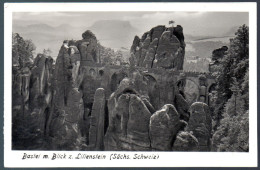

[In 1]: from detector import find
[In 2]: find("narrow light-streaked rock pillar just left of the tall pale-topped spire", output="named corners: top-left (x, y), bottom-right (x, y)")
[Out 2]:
top-left (29, 54), bottom-right (53, 133)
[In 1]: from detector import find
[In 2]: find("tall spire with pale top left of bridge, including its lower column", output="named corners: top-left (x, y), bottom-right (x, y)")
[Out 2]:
top-left (46, 42), bottom-right (84, 149)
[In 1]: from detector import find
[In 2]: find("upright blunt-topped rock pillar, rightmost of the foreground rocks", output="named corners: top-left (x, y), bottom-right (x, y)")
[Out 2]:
top-left (187, 102), bottom-right (212, 151)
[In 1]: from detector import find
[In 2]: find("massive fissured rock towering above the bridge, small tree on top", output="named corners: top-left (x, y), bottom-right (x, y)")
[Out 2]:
top-left (129, 25), bottom-right (185, 70)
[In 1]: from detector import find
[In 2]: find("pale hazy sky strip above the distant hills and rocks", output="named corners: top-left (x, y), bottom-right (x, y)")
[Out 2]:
top-left (13, 12), bottom-right (249, 35)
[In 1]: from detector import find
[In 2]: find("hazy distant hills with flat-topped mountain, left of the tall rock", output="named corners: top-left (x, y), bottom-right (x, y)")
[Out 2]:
top-left (13, 20), bottom-right (139, 58)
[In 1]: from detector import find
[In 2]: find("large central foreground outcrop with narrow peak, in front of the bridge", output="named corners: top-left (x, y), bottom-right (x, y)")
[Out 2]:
top-left (105, 79), bottom-right (151, 150)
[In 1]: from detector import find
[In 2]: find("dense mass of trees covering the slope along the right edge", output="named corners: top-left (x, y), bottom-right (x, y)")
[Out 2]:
top-left (213, 25), bottom-right (249, 151)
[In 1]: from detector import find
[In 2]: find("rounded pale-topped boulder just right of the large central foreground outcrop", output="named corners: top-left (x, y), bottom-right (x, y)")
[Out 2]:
top-left (149, 104), bottom-right (181, 151)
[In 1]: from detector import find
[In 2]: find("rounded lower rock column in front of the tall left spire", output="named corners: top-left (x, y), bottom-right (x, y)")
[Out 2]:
top-left (49, 89), bottom-right (84, 150)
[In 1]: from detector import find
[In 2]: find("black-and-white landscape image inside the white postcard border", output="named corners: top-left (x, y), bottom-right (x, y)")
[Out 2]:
top-left (12, 11), bottom-right (249, 153)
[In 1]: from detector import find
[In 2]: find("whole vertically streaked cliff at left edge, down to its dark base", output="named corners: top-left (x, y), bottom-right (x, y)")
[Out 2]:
top-left (12, 54), bottom-right (53, 149)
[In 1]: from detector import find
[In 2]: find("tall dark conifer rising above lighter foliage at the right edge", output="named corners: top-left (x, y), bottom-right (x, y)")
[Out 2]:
top-left (213, 25), bottom-right (249, 130)
